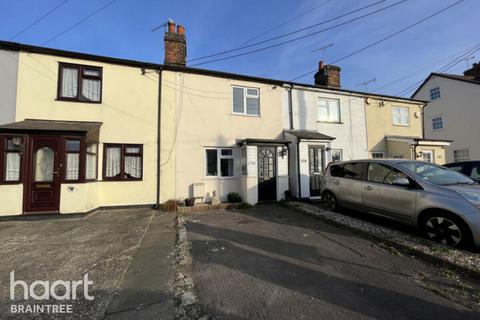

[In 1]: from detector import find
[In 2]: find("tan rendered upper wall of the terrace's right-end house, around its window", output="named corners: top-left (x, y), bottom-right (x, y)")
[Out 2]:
top-left (365, 97), bottom-right (422, 156)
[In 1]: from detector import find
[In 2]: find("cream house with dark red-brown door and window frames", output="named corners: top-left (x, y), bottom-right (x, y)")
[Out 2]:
top-left (0, 42), bottom-right (159, 215)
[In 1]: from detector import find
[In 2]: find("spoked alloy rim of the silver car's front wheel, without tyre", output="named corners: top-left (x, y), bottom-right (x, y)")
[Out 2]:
top-left (425, 216), bottom-right (462, 246)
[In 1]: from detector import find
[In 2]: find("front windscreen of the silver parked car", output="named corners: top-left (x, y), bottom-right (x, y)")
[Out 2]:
top-left (399, 161), bottom-right (475, 186)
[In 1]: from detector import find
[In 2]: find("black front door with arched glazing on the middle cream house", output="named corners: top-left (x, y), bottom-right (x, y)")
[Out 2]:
top-left (258, 147), bottom-right (277, 201)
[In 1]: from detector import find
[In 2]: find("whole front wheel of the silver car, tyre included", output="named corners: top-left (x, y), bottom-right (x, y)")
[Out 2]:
top-left (422, 213), bottom-right (471, 247)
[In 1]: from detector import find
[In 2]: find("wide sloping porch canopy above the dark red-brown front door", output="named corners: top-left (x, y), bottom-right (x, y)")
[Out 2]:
top-left (0, 119), bottom-right (102, 142)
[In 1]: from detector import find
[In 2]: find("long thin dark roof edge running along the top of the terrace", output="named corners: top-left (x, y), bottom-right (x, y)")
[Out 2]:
top-left (0, 40), bottom-right (426, 103)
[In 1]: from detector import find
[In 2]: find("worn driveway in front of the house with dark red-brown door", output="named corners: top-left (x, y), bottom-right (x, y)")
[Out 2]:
top-left (0, 209), bottom-right (175, 320)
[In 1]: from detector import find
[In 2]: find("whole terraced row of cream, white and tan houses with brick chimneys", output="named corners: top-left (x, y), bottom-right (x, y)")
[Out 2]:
top-left (0, 22), bottom-right (447, 215)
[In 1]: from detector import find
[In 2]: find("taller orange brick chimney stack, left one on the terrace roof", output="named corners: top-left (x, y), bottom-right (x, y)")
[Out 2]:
top-left (163, 19), bottom-right (187, 66)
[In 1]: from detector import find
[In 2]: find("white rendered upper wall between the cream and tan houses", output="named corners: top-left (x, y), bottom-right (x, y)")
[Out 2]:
top-left (283, 88), bottom-right (368, 160)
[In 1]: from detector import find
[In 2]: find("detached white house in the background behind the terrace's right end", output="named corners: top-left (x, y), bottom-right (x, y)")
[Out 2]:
top-left (412, 63), bottom-right (480, 162)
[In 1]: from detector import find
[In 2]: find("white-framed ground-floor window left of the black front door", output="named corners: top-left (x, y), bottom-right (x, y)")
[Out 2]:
top-left (205, 148), bottom-right (234, 177)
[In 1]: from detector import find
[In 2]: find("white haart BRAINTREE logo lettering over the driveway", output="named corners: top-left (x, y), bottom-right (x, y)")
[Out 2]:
top-left (10, 271), bottom-right (94, 313)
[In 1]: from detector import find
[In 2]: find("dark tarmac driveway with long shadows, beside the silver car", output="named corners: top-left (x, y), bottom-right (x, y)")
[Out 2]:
top-left (187, 205), bottom-right (480, 320)
